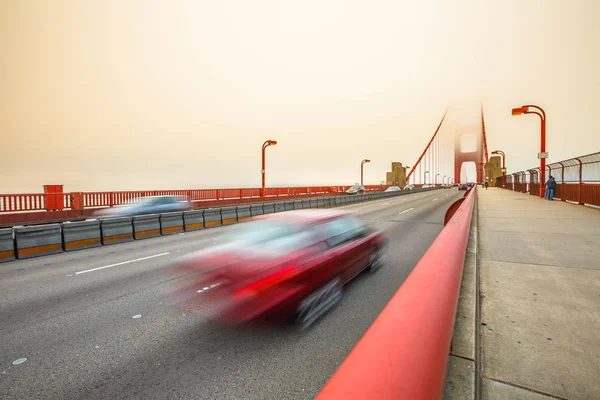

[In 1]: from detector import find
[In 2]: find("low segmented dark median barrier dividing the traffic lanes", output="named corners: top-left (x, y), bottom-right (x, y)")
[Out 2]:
top-left (0, 188), bottom-right (435, 262)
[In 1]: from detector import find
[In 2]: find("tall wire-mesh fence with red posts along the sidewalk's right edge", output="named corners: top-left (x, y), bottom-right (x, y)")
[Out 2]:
top-left (496, 152), bottom-right (600, 206)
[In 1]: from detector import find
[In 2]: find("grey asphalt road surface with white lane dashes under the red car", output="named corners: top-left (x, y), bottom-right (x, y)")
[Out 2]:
top-left (0, 189), bottom-right (464, 400)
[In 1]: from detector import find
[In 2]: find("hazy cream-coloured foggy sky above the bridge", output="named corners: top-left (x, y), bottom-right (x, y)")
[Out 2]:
top-left (0, 0), bottom-right (600, 193)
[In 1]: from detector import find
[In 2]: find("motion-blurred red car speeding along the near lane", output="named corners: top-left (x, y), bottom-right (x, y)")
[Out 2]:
top-left (166, 210), bottom-right (386, 328)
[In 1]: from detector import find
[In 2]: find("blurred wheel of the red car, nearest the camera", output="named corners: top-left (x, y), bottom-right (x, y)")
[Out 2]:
top-left (296, 278), bottom-right (342, 330)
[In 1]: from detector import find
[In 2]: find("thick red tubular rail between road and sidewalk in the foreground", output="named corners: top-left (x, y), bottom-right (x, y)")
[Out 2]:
top-left (317, 189), bottom-right (475, 400)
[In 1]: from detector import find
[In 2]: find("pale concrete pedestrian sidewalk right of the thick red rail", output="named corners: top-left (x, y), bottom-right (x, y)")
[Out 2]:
top-left (476, 188), bottom-right (600, 400)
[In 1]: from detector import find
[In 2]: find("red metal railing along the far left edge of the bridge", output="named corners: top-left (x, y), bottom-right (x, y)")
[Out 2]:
top-left (0, 185), bottom-right (387, 213)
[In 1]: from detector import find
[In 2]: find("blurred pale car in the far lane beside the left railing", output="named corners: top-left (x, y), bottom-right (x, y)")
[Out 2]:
top-left (95, 196), bottom-right (191, 217)
